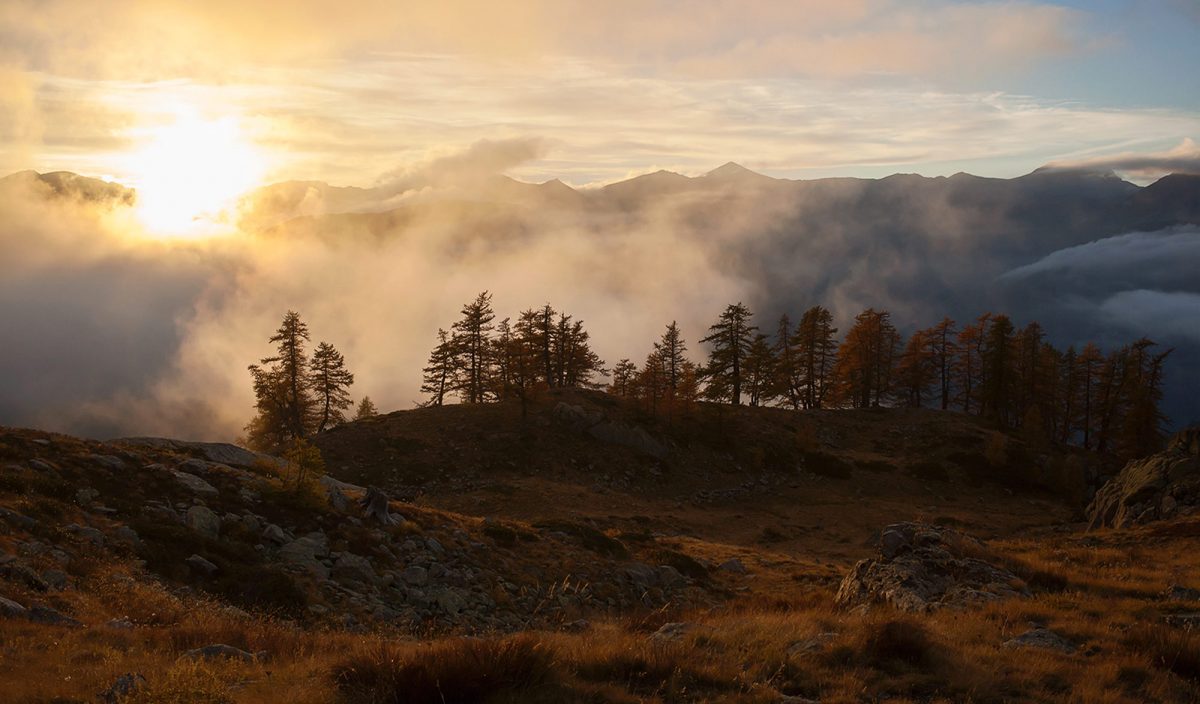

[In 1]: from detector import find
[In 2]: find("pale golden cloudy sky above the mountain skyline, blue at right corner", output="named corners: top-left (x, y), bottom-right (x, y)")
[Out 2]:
top-left (0, 0), bottom-right (1200, 187)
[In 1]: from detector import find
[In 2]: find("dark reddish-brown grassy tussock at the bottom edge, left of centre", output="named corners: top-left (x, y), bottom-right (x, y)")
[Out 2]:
top-left (332, 634), bottom-right (554, 704)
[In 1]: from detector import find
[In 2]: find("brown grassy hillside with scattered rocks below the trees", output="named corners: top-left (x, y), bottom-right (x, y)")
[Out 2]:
top-left (0, 391), bottom-right (1200, 704)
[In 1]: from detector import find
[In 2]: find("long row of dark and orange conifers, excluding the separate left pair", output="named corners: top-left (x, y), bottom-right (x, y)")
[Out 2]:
top-left (420, 291), bottom-right (1171, 457)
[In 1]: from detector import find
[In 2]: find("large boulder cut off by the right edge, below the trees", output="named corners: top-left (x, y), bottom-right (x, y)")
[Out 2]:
top-left (1087, 427), bottom-right (1200, 529)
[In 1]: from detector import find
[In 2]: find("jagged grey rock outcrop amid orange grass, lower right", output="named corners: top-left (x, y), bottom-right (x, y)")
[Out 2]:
top-left (836, 523), bottom-right (1026, 613)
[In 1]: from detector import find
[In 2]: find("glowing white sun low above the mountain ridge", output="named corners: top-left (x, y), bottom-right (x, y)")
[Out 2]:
top-left (128, 113), bottom-right (265, 236)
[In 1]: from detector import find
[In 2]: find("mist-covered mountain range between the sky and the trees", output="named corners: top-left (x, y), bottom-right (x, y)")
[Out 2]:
top-left (0, 144), bottom-right (1200, 440)
